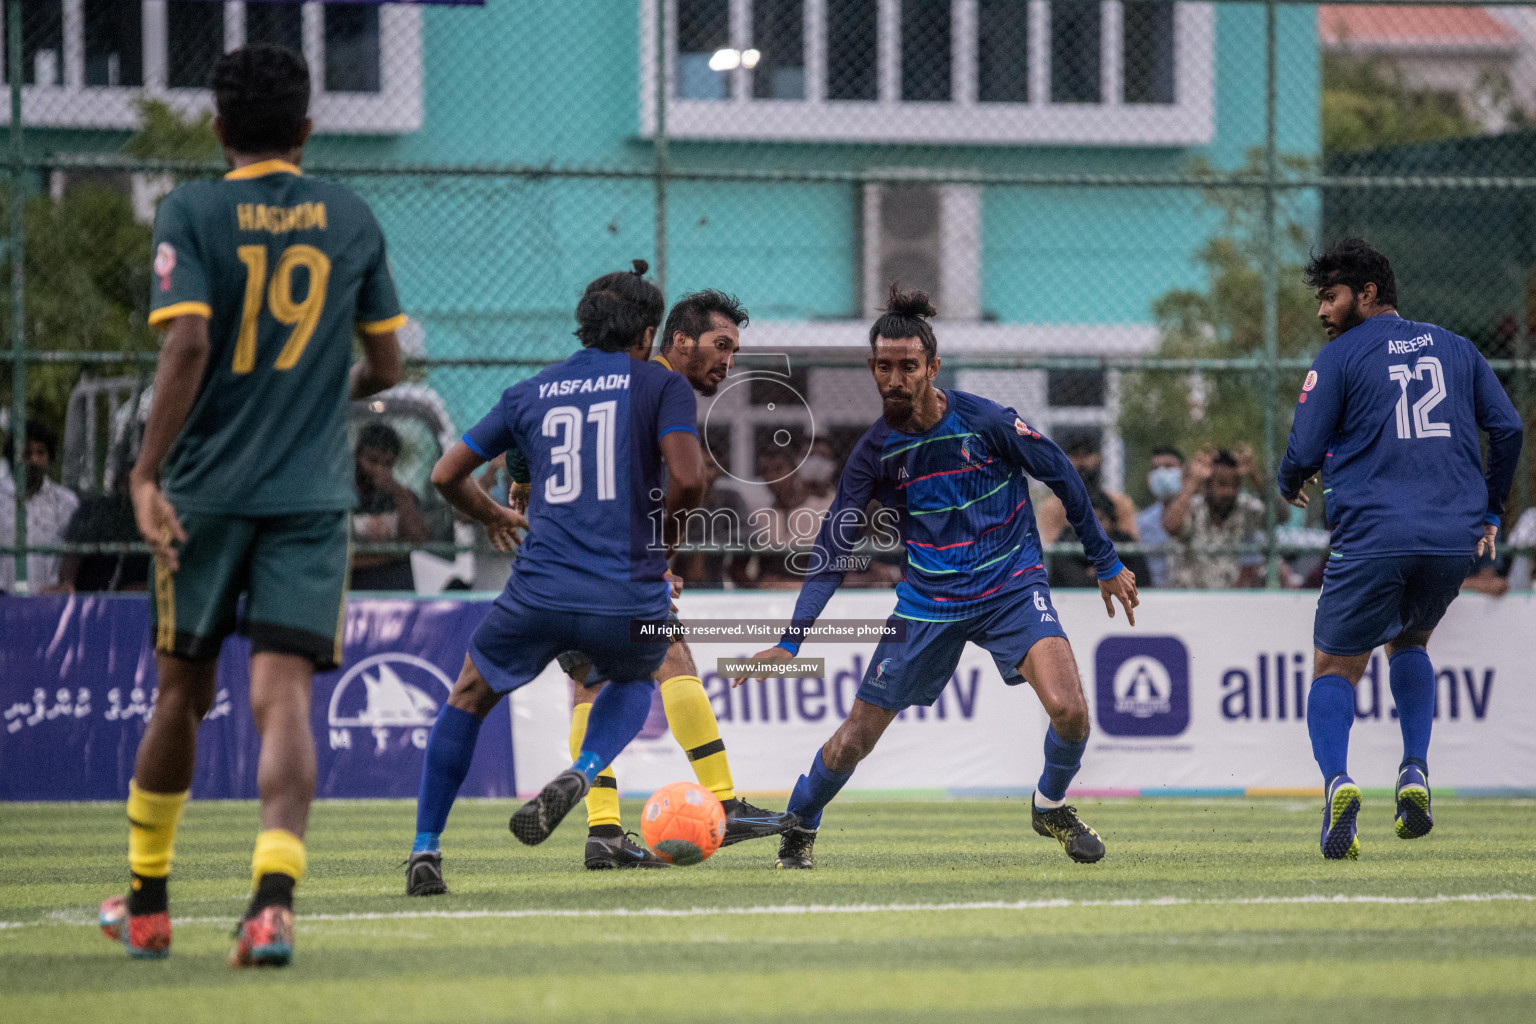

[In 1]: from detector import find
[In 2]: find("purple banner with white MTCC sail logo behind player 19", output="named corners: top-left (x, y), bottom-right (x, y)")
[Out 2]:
top-left (0, 594), bottom-right (516, 800)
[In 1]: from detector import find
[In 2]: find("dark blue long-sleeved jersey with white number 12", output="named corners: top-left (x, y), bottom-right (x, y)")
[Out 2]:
top-left (1276, 313), bottom-right (1524, 557)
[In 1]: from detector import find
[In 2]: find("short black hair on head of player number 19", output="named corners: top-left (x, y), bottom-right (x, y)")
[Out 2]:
top-left (209, 43), bottom-right (309, 154)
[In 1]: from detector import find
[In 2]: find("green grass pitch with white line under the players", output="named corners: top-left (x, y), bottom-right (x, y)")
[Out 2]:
top-left (0, 797), bottom-right (1536, 1024)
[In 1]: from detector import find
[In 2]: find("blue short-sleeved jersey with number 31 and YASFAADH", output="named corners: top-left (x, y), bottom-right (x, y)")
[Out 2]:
top-left (464, 348), bottom-right (697, 619)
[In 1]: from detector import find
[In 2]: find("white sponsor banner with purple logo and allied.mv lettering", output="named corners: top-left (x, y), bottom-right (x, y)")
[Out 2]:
top-left (513, 591), bottom-right (1536, 792)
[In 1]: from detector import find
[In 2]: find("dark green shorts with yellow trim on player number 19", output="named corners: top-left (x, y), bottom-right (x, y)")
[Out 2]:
top-left (151, 511), bottom-right (350, 671)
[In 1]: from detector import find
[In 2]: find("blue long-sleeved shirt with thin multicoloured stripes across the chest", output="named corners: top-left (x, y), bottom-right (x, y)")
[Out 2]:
top-left (780, 391), bottom-right (1123, 651)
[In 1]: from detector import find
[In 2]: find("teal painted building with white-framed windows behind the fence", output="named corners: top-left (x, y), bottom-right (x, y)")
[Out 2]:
top-left (23, 0), bottom-right (1319, 479)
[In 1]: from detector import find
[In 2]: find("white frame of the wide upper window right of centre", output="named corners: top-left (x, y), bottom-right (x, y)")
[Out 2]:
top-left (639, 0), bottom-right (1217, 146)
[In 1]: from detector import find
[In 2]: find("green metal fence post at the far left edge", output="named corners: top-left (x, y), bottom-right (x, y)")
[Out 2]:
top-left (6, 0), bottom-right (28, 594)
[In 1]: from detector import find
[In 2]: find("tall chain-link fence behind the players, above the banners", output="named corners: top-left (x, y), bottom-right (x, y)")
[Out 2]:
top-left (0, 0), bottom-right (1536, 593)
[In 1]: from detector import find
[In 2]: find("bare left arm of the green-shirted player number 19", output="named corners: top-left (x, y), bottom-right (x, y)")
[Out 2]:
top-left (127, 313), bottom-right (209, 573)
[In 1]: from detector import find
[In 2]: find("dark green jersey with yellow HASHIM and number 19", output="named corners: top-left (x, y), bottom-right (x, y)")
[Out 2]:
top-left (149, 160), bottom-right (406, 516)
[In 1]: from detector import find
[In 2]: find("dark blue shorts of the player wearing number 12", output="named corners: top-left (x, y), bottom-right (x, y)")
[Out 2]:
top-left (1312, 554), bottom-right (1471, 657)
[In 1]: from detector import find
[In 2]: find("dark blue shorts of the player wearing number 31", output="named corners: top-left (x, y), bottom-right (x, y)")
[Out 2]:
top-left (470, 597), bottom-right (668, 694)
